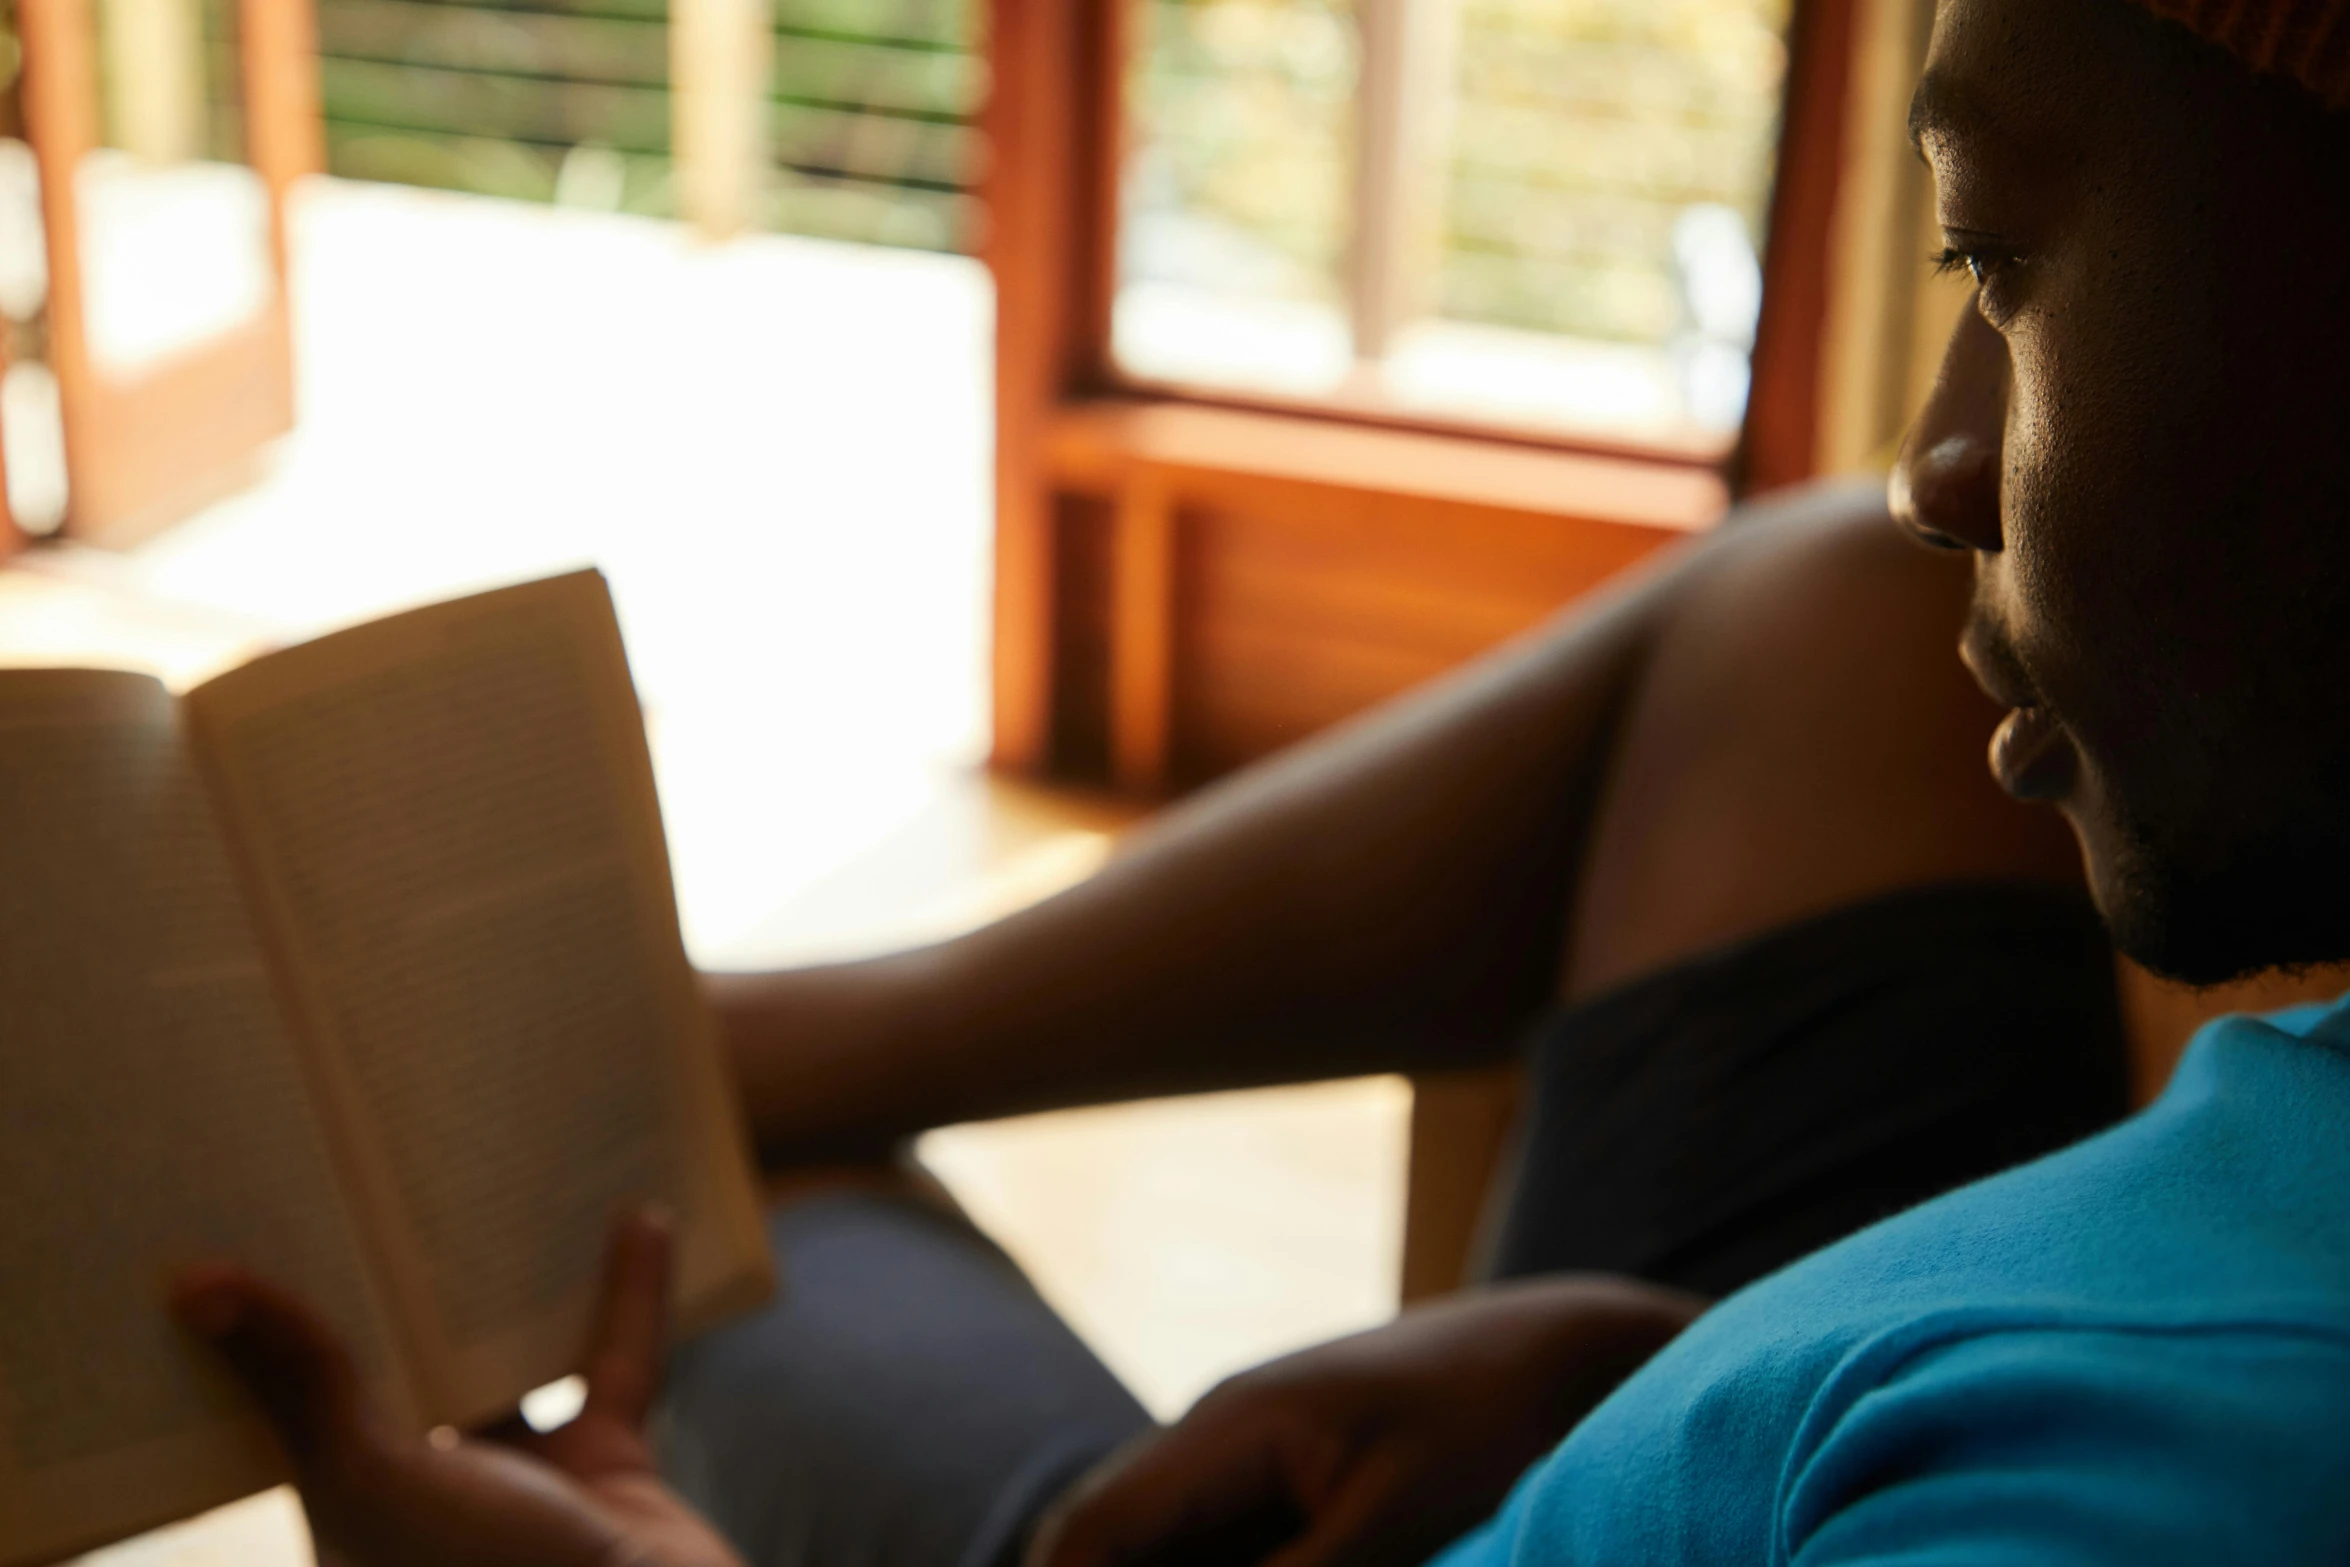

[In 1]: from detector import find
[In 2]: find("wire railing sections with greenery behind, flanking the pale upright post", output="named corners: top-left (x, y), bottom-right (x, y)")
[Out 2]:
top-left (264, 0), bottom-right (985, 249)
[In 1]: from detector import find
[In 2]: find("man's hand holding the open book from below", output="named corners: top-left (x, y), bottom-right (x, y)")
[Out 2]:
top-left (172, 1217), bottom-right (743, 1567)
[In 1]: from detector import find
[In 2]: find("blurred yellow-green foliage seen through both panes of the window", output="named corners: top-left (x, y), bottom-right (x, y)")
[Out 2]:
top-left (1128, 0), bottom-right (1791, 343)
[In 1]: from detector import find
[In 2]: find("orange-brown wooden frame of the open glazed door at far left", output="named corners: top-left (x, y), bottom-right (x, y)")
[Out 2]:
top-left (16, 0), bottom-right (324, 540)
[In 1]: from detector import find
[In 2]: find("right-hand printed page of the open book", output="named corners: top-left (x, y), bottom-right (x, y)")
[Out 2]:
top-left (188, 573), bottom-right (766, 1424)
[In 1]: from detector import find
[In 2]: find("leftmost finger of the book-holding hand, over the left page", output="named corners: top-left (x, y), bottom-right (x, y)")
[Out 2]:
top-left (172, 1264), bottom-right (367, 1468)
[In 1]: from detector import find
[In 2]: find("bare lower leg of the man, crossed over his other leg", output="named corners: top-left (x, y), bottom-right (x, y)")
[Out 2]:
top-left (710, 491), bottom-right (1889, 1161)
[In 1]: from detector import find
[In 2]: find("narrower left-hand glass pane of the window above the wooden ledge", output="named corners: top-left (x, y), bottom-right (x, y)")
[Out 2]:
top-left (1116, 0), bottom-right (1356, 392)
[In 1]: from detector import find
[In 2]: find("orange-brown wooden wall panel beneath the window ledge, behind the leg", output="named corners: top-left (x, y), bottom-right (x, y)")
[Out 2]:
top-left (1173, 486), bottom-right (1683, 782)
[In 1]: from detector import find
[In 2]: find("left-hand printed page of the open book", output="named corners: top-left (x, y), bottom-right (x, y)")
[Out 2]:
top-left (0, 670), bottom-right (407, 1562)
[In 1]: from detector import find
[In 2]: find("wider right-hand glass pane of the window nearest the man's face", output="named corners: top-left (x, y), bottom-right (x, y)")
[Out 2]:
top-left (1387, 0), bottom-right (1788, 435)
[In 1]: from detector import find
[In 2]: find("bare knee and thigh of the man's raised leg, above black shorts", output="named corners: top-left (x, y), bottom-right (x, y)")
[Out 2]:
top-left (1570, 486), bottom-right (2077, 994)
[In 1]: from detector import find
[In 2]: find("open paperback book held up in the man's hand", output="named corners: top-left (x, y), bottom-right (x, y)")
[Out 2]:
top-left (0, 573), bottom-right (771, 1565)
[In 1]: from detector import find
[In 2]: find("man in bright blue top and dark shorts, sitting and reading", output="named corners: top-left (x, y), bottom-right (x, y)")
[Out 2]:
top-left (173, 0), bottom-right (2350, 1567)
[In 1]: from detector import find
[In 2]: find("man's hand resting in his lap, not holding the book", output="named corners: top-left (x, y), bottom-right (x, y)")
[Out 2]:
top-left (1027, 1278), bottom-right (1704, 1567)
